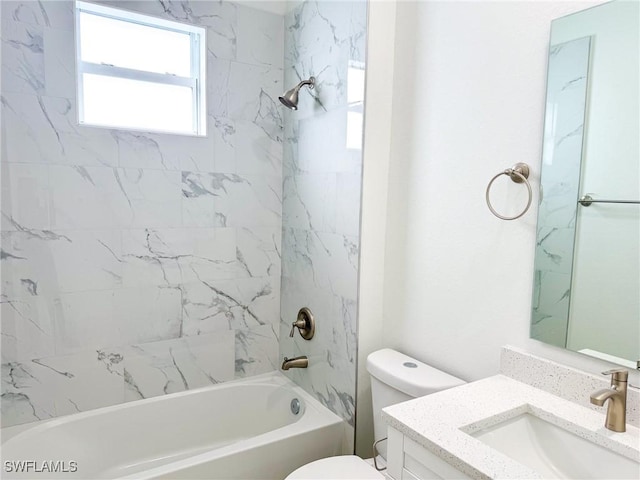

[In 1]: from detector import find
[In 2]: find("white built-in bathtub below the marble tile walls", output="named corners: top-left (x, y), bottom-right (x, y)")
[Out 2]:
top-left (0, 372), bottom-right (347, 479)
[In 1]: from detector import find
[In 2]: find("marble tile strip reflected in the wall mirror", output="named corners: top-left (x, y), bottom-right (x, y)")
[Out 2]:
top-left (531, 37), bottom-right (591, 347)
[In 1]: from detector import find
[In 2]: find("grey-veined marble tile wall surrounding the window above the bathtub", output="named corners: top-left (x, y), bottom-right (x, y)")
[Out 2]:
top-left (0, 0), bottom-right (284, 426)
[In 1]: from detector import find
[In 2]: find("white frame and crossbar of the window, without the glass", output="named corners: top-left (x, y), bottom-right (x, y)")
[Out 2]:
top-left (74, 0), bottom-right (207, 137)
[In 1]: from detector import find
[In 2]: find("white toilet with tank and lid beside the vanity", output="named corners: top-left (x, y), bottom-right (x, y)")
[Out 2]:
top-left (285, 348), bottom-right (465, 480)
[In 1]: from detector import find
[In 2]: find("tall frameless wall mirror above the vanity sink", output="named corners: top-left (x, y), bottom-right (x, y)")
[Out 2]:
top-left (531, 0), bottom-right (640, 368)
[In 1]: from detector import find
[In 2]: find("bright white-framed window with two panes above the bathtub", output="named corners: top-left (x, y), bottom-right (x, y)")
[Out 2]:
top-left (76, 1), bottom-right (206, 136)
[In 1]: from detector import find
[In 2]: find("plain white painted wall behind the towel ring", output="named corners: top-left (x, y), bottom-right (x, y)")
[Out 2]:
top-left (376, 1), bottom-right (640, 380)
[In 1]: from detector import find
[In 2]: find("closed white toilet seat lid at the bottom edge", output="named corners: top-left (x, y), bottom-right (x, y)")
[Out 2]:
top-left (285, 455), bottom-right (385, 480)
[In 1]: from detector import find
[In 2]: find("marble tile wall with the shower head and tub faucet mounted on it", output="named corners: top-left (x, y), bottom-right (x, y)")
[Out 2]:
top-left (280, 1), bottom-right (367, 450)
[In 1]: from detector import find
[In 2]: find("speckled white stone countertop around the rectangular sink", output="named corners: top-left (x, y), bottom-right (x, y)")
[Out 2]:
top-left (382, 375), bottom-right (640, 479)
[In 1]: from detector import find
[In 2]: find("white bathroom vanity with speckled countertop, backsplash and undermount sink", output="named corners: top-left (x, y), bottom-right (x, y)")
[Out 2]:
top-left (383, 347), bottom-right (640, 480)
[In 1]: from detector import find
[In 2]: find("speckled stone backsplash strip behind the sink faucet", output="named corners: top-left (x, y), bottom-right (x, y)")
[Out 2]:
top-left (500, 346), bottom-right (640, 428)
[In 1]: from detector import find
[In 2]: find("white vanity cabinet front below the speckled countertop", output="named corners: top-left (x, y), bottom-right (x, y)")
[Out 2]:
top-left (387, 427), bottom-right (471, 480)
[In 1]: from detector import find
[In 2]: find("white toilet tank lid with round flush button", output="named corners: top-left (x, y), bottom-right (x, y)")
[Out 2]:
top-left (367, 348), bottom-right (466, 397)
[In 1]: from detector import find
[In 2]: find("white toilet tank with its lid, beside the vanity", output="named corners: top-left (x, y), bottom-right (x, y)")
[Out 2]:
top-left (367, 348), bottom-right (466, 459)
